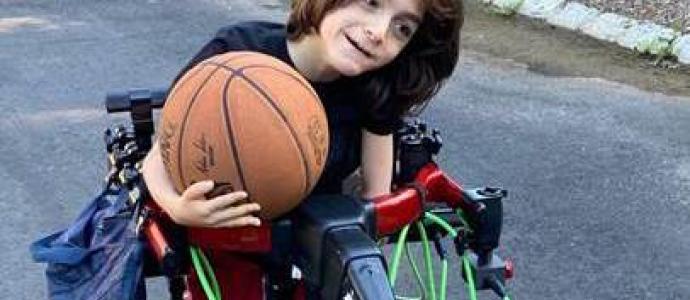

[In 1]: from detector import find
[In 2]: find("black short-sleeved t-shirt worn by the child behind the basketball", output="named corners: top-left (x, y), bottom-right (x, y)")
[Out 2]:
top-left (175, 22), bottom-right (399, 194)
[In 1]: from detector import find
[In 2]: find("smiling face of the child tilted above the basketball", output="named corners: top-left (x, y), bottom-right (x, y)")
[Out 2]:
top-left (319, 0), bottom-right (424, 76)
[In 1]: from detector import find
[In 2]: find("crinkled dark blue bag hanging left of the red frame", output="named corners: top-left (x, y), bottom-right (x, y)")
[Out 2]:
top-left (30, 189), bottom-right (146, 300)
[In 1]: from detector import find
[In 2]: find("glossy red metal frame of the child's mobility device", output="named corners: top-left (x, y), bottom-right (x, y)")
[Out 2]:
top-left (144, 163), bottom-right (464, 300)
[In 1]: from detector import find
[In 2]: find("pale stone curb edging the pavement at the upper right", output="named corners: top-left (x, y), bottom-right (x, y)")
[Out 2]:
top-left (474, 0), bottom-right (690, 65)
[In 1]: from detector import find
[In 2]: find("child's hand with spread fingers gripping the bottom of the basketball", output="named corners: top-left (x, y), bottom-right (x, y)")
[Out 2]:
top-left (170, 180), bottom-right (261, 228)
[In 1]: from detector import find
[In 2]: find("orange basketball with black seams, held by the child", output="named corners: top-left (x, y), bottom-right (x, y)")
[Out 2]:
top-left (158, 52), bottom-right (328, 220)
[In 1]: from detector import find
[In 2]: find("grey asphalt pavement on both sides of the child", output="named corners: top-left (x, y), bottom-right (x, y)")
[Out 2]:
top-left (0, 0), bottom-right (690, 300)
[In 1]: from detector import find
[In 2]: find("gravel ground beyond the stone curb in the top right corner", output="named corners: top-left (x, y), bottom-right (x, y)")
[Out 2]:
top-left (571, 0), bottom-right (690, 33)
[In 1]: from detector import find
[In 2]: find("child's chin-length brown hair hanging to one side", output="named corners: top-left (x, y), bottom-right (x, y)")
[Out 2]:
top-left (287, 0), bottom-right (464, 116)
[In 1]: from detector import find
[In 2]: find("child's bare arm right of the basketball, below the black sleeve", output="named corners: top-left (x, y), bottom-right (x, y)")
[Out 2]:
top-left (354, 129), bottom-right (393, 199)
